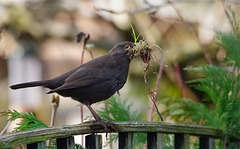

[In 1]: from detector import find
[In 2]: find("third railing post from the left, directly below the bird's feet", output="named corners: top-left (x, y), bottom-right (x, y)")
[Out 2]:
top-left (85, 134), bottom-right (102, 149)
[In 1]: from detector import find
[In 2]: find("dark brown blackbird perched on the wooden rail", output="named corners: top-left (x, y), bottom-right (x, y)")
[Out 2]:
top-left (10, 41), bottom-right (134, 131)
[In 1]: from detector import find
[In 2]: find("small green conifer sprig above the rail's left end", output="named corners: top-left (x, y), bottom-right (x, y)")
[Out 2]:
top-left (0, 110), bottom-right (48, 132)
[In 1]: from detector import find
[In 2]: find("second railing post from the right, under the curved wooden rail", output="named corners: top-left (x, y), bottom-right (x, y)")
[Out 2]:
top-left (174, 133), bottom-right (189, 149)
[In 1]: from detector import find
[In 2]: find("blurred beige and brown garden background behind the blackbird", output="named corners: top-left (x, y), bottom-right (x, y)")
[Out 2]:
top-left (0, 0), bottom-right (240, 147)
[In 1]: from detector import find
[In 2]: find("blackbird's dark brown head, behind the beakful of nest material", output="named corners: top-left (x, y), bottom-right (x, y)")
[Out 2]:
top-left (109, 41), bottom-right (135, 60)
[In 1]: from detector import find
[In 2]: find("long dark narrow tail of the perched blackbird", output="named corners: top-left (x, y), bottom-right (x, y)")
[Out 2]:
top-left (10, 81), bottom-right (47, 90)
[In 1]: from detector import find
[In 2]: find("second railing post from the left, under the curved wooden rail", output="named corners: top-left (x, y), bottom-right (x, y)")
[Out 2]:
top-left (56, 136), bottom-right (74, 149)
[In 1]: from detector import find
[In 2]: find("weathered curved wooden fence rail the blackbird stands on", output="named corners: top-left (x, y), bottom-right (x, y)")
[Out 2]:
top-left (0, 122), bottom-right (222, 149)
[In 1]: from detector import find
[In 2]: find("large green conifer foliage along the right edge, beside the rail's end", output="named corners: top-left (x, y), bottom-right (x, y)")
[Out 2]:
top-left (164, 12), bottom-right (240, 148)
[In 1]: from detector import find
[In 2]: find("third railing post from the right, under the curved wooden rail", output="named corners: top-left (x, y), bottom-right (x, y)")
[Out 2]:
top-left (147, 132), bottom-right (164, 149)
